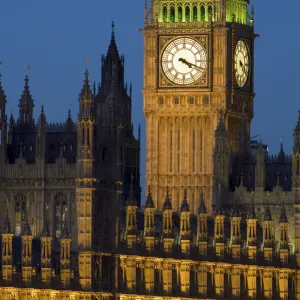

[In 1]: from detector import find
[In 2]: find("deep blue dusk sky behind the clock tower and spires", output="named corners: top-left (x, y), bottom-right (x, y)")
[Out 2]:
top-left (0, 0), bottom-right (300, 197)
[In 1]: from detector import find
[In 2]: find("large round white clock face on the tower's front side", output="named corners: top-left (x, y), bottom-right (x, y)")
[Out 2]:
top-left (161, 38), bottom-right (207, 85)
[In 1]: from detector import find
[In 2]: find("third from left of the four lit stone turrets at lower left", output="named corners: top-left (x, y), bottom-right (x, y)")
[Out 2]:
top-left (41, 204), bottom-right (52, 285)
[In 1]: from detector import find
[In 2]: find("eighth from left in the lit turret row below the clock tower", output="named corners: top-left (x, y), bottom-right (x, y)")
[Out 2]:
top-left (247, 195), bottom-right (257, 263)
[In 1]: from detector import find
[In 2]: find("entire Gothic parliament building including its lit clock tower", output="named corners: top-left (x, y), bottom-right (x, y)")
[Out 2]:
top-left (0, 0), bottom-right (300, 300)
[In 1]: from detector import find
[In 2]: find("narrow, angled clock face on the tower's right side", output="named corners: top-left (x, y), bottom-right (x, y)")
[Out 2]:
top-left (234, 40), bottom-right (250, 87)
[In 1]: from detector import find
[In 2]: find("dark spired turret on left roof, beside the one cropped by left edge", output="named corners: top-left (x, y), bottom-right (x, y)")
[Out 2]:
top-left (19, 75), bottom-right (34, 125)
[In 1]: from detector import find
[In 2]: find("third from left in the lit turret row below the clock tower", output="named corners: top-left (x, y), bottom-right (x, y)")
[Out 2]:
top-left (163, 188), bottom-right (174, 253)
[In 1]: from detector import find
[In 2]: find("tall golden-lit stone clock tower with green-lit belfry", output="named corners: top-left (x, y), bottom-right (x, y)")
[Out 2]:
top-left (143, 0), bottom-right (255, 213)
